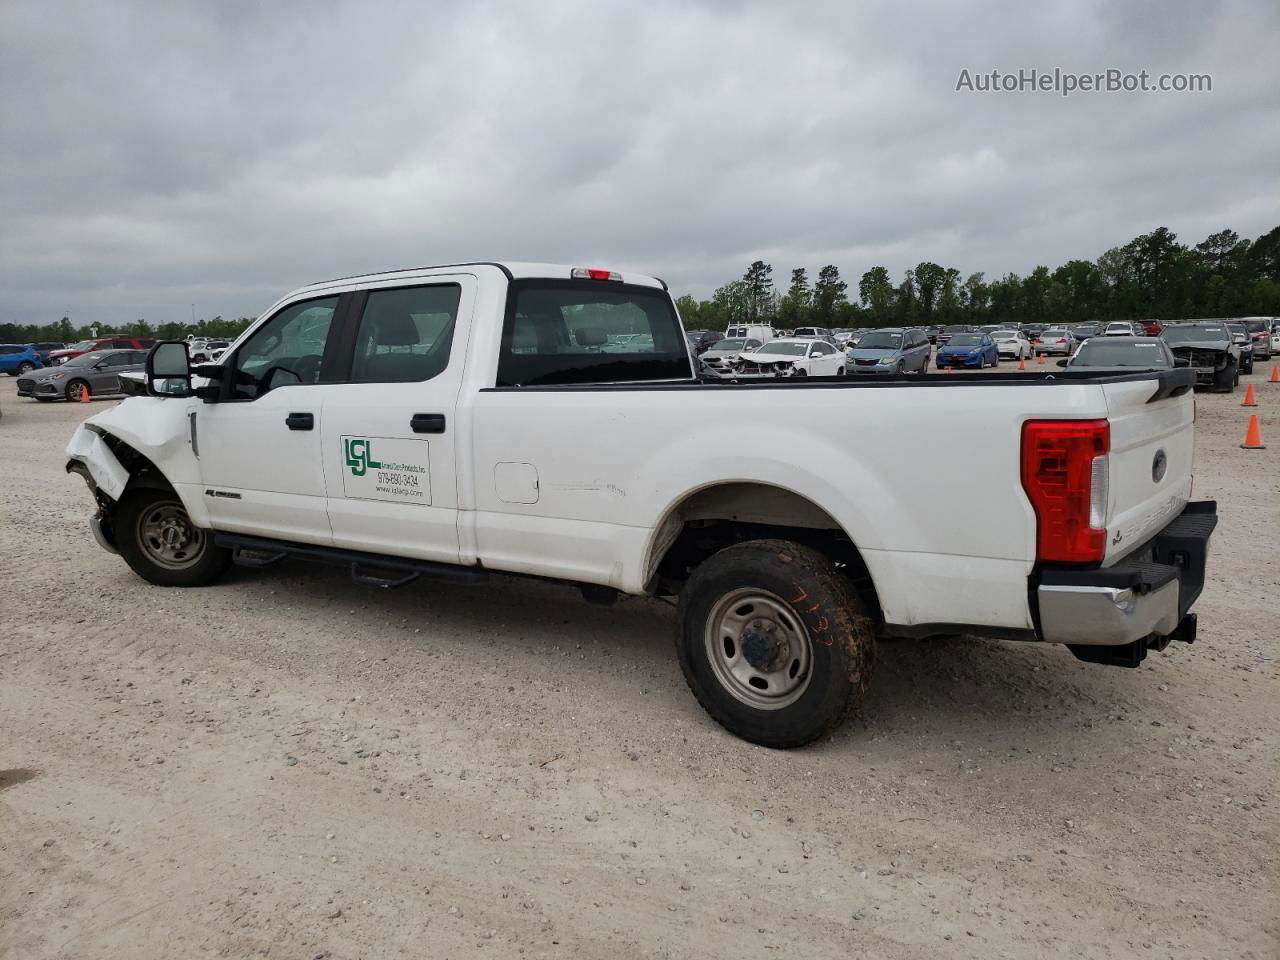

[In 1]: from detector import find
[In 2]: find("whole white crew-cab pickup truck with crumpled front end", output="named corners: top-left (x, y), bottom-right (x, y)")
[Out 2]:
top-left (68, 262), bottom-right (1216, 748)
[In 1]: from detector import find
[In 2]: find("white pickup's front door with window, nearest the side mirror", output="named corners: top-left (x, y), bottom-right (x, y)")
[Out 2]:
top-left (192, 296), bottom-right (339, 544)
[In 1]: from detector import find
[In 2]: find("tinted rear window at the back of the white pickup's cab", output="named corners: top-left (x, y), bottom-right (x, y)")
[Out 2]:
top-left (497, 280), bottom-right (692, 387)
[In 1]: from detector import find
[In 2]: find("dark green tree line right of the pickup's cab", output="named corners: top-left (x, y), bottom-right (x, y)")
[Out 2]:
top-left (676, 227), bottom-right (1280, 330)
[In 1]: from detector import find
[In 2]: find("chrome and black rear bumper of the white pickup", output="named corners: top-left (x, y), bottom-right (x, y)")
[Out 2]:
top-left (1033, 500), bottom-right (1217, 666)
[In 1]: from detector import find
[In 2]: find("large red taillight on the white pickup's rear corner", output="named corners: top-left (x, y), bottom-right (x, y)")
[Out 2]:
top-left (1023, 420), bottom-right (1111, 563)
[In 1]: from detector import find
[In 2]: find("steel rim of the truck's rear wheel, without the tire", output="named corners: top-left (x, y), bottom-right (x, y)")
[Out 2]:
top-left (704, 588), bottom-right (813, 710)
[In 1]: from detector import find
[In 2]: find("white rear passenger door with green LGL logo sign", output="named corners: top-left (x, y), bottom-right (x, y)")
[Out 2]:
top-left (324, 275), bottom-right (476, 563)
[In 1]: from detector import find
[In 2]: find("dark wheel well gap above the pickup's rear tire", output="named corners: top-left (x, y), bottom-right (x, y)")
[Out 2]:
top-left (650, 483), bottom-right (879, 616)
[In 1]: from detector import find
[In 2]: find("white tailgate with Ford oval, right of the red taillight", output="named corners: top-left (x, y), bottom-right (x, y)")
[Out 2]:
top-left (1102, 370), bottom-right (1196, 566)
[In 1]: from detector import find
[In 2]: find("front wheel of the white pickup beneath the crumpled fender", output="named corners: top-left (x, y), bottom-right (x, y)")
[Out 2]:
top-left (113, 489), bottom-right (232, 586)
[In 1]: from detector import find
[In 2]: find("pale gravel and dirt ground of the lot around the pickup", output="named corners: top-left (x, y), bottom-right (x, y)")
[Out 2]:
top-left (0, 365), bottom-right (1280, 960)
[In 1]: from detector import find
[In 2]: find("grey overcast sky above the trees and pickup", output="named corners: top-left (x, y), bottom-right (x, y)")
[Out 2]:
top-left (0, 0), bottom-right (1280, 324)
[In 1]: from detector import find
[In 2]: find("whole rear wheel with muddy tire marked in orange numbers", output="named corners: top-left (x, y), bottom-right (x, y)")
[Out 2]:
top-left (676, 540), bottom-right (876, 749)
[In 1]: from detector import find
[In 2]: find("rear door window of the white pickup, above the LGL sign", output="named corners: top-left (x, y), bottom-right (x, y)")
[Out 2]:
top-left (351, 283), bottom-right (462, 383)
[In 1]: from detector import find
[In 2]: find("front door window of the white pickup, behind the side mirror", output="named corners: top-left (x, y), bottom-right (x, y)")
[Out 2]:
top-left (230, 297), bottom-right (338, 399)
